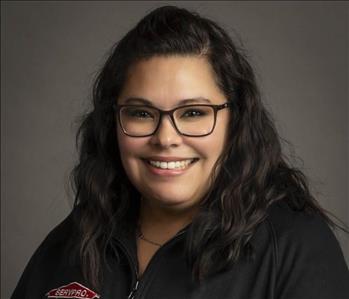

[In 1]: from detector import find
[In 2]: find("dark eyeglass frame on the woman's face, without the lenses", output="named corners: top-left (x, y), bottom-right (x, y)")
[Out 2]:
top-left (113, 102), bottom-right (231, 138)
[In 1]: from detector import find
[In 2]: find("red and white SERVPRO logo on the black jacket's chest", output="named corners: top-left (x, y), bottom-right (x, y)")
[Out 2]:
top-left (46, 282), bottom-right (99, 299)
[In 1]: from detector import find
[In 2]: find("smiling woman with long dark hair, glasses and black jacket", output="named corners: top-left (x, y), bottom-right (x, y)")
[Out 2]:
top-left (12, 6), bottom-right (349, 299)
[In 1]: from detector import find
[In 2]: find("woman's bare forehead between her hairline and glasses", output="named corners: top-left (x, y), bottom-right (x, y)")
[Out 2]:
top-left (118, 55), bottom-right (224, 108)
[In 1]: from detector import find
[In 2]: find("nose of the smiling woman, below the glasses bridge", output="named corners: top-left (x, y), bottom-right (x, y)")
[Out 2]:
top-left (151, 115), bottom-right (182, 148)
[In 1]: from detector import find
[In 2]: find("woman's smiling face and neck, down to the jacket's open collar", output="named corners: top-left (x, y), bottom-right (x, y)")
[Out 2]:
top-left (117, 55), bottom-right (229, 275)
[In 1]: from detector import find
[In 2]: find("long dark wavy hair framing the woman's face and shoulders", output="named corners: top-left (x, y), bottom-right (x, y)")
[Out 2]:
top-left (71, 6), bottom-right (346, 288)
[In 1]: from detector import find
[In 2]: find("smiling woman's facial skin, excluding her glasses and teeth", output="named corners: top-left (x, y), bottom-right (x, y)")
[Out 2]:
top-left (117, 56), bottom-right (229, 211)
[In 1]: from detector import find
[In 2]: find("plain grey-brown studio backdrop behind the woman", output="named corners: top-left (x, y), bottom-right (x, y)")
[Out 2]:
top-left (1, 1), bottom-right (349, 298)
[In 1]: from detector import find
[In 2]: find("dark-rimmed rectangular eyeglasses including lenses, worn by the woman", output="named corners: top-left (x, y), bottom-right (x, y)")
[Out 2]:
top-left (113, 102), bottom-right (230, 137)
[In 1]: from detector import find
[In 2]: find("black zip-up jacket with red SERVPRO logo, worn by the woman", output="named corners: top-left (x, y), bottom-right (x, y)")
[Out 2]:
top-left (12, 203), bottom-right (349, 299)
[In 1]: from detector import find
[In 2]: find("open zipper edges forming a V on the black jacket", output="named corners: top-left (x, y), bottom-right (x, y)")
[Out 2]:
top-left (116, 227), bottom-right (187, 299)
